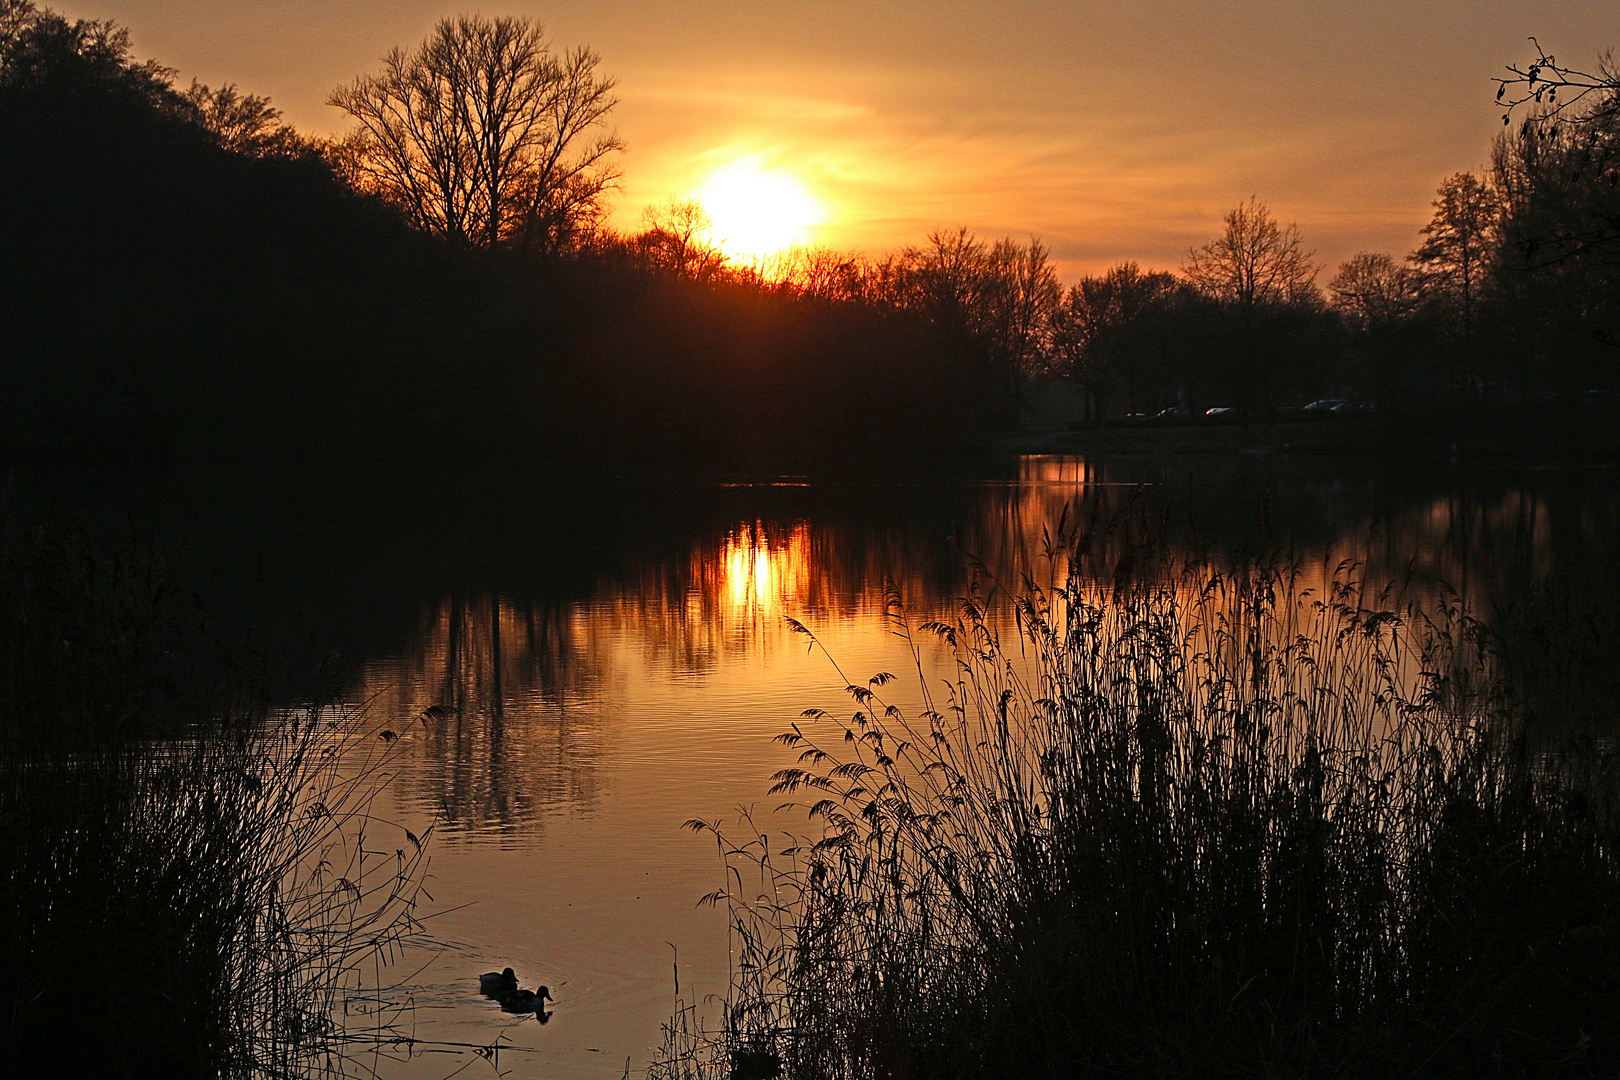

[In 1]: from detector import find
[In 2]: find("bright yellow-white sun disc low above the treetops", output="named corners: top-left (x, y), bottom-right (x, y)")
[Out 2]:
top-left (698, 160), bottom-right (823, 259)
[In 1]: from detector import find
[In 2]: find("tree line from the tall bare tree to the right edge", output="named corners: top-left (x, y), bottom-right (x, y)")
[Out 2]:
top-left (306, 8), bottom-right (1620, 418)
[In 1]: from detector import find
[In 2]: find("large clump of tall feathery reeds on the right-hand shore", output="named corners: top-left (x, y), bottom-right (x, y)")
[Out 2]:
top-left (661, 513), bottom-right (1620, 1080)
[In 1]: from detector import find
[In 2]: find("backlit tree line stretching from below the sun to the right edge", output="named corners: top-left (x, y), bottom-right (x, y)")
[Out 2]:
top-left (609, 53), bottom-right (1620, 418)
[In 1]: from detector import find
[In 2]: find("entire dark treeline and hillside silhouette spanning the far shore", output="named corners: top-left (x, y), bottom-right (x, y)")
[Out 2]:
top-left (9, 0), bottom-right (1620, 473)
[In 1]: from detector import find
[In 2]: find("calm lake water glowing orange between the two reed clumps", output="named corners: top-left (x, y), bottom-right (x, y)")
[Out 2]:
top-left (246, 455), bottom-right (1620, 1077)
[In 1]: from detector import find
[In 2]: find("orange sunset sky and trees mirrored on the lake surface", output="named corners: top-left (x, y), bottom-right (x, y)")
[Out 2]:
top-left (345, 457), bottom-right (1617, 1077)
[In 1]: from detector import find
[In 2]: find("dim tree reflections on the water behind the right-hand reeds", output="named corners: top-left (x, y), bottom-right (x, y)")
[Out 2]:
top-left (967, 455), bottom-right (1620, 607)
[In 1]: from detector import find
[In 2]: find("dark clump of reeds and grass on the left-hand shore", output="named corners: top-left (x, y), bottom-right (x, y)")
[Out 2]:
top-left (0, 533), bottom-right (426, 1077)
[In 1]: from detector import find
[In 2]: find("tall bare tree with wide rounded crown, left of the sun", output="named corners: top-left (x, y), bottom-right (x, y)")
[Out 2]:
top-left (329, 16), bottom-right (622, 248)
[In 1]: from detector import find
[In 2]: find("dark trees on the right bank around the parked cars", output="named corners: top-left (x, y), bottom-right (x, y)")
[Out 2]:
top-left (1017, 55), bottom-right (1620, 439)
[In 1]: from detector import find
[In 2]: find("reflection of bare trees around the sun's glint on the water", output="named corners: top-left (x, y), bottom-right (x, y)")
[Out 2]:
top-left (356, 520), bottom-right (954, 834)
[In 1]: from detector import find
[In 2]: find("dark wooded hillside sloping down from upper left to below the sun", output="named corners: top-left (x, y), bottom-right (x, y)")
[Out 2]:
top-left (0, 0), bottom-right (980, 488)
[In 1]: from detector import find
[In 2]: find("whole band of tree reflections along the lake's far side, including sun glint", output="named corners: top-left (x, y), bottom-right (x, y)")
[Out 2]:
top-left (351, 457), bottom-right (1620, 832)
